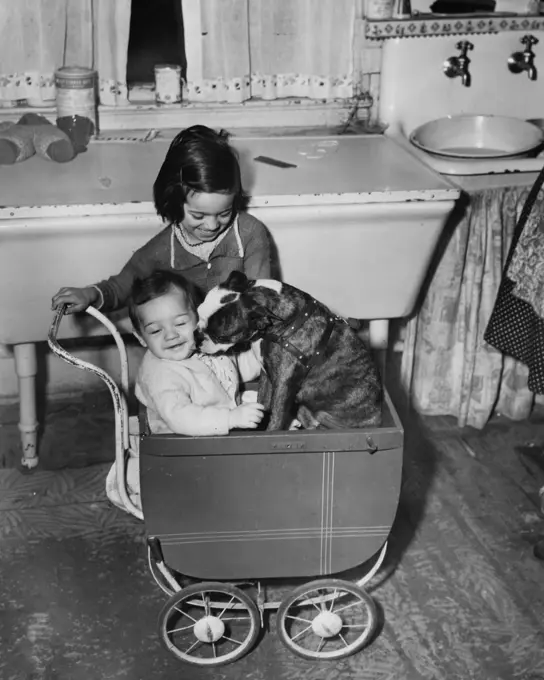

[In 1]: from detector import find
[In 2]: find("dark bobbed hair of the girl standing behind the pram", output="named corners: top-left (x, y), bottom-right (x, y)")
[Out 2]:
top-left (153, 125), bottom-right (247, 224)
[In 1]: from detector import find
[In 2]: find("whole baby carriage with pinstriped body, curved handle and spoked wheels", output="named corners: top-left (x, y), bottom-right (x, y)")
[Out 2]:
top-left (49, 307), bottom-right (403, 667)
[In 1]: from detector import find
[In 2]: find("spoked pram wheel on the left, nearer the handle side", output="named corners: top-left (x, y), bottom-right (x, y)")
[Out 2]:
top-left (159, 582), bottom-right (261, 666)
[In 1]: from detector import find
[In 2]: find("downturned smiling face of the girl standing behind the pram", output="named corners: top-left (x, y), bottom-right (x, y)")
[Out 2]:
top-left (181, 192), bottom-right (234, 244)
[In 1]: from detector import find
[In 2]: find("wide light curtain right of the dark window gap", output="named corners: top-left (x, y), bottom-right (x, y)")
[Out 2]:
top-left (182, 0), bottom-right (358, 102)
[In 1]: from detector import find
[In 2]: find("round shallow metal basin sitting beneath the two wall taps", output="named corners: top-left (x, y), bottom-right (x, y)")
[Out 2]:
top-left (410, 115), bottom-right (544, 159)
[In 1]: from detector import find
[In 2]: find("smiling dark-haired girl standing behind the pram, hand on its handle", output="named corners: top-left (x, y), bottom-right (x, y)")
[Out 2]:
top-left (52, 125), bottom-right (271, 313)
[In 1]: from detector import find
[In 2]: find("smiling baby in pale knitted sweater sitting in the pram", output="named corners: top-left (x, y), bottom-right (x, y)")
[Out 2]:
top-left (129, 270), bottom-right (264, 436)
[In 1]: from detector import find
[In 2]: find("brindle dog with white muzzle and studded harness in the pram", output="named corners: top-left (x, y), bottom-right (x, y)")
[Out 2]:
top-left (197, 272), bottom-right (383, 430)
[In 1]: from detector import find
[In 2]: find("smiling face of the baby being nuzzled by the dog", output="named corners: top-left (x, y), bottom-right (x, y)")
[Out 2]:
top-left (138, 287), bottom-right (198, 361)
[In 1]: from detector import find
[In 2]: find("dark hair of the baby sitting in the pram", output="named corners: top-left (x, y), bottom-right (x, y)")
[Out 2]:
top-left (128, 269), bottom-right (203, 331)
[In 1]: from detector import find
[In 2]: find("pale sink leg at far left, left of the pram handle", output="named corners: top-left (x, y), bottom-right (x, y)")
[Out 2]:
top-left (13, 343), bottom-right (38, 470)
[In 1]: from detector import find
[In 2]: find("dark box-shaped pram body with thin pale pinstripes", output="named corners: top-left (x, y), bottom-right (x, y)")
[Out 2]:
top-left (140, 395), bottom-right (403, 580)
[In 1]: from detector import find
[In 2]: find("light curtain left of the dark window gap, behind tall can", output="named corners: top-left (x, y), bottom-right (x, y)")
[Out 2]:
top-left (0, 0), bottom-right (131, 106)
